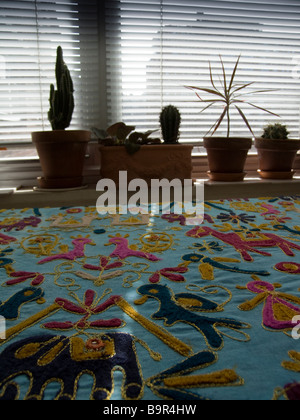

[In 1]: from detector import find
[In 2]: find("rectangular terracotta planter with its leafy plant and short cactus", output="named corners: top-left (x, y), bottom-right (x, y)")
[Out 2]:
top-left (92, 105), bottom-right (193, 185)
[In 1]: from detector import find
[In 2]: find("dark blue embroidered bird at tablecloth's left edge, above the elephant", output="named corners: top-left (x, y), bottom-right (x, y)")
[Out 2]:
top-left (0, 287), bottom-right (44, 321)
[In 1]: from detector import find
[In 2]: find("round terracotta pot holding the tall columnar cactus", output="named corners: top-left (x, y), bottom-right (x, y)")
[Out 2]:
top-left (32, 130), bottom-right (91, 189)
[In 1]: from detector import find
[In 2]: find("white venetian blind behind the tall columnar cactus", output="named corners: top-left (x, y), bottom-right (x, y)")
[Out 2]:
top-left (0, 0), bottom-right (100, 143)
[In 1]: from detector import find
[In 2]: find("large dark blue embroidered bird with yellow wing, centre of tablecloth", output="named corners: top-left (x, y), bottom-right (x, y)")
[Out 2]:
top-left (135, 284), bottom-right (250, 350)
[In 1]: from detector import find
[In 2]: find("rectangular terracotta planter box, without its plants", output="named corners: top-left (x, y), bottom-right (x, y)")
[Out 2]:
top-left (100, 144), bottom-right (193, 185)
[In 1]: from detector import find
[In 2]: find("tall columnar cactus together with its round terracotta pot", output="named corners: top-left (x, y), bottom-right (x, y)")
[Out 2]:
top-left (32, 46), bottom-right (91, 189)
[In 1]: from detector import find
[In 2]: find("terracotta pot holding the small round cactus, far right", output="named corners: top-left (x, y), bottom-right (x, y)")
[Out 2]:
top-left (255, 138), bottom-right (300, 179)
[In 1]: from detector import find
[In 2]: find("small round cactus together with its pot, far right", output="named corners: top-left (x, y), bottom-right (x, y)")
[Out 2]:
top-left (255, 123), bottom-right (300, 179)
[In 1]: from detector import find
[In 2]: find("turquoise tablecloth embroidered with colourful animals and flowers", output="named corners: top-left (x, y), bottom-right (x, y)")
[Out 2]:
top-left (0, 197), bottom-right (300, 400)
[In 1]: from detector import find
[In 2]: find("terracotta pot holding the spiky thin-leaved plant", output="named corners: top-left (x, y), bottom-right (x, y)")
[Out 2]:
top-left (204, 137), bottom-right (252, 182)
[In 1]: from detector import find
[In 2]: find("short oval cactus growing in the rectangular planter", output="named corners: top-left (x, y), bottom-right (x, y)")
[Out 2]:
top-left (160, 105), bottom-right (181, 144)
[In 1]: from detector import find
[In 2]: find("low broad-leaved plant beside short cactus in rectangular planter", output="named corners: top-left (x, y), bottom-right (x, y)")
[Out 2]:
top-left (92, 122), bottom-right (160, 155)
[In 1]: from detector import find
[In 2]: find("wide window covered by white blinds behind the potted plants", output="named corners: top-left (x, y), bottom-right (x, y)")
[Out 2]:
top-left (0, 0), bottom-right (300, 158)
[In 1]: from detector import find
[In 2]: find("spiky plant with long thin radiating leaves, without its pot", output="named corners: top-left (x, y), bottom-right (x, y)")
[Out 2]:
top-left (186, 56), bottom-right (279, 137)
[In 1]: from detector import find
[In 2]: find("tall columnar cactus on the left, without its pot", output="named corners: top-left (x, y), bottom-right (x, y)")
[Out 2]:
top-left (48, 47), bottom-right (74, 130)
